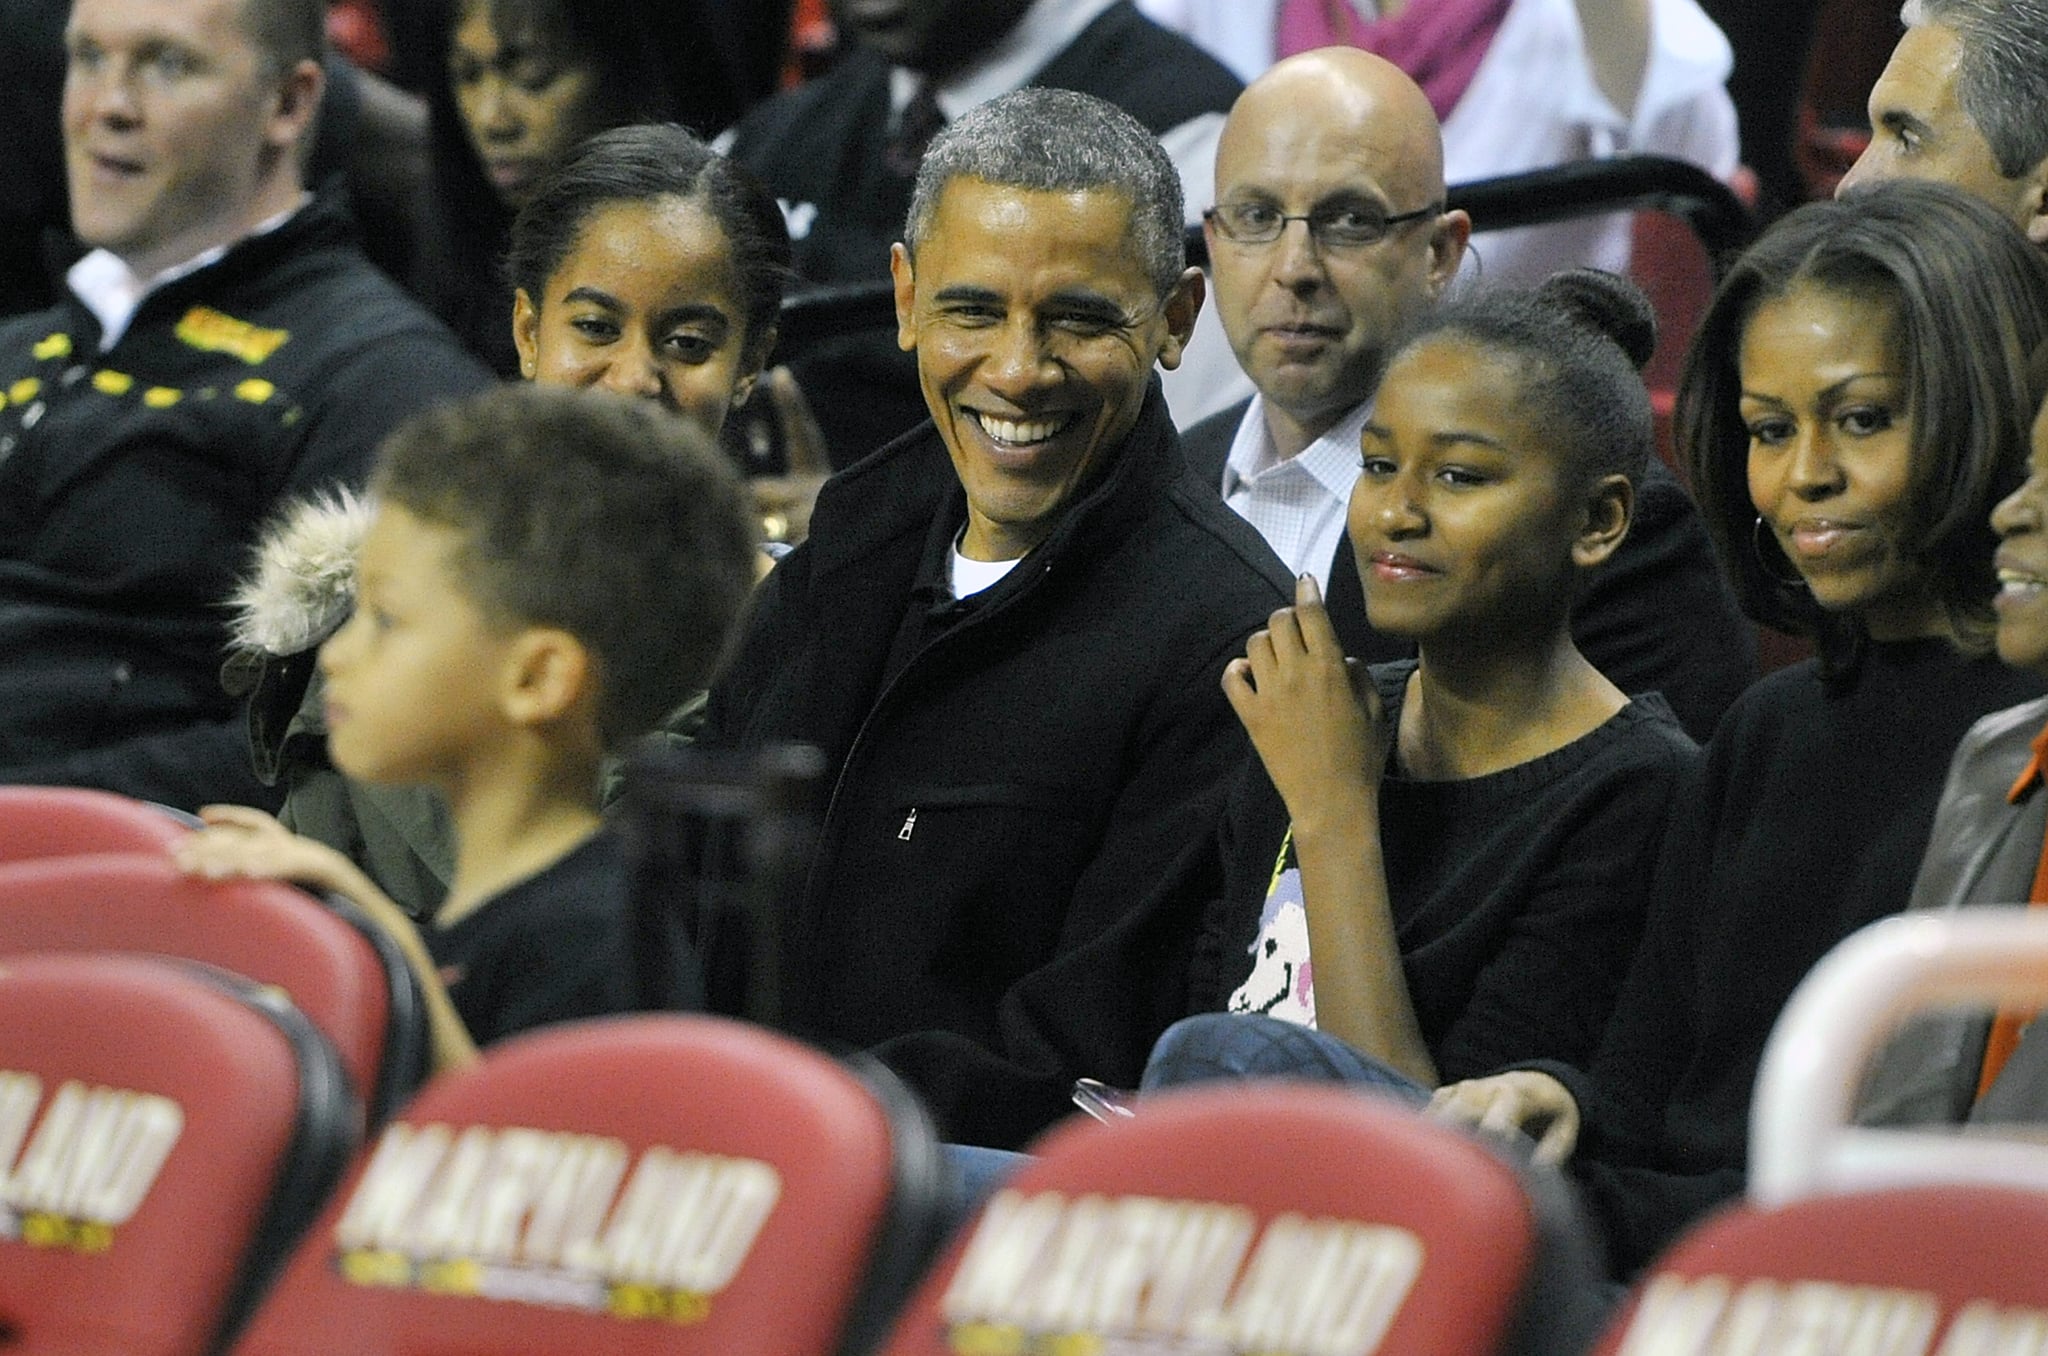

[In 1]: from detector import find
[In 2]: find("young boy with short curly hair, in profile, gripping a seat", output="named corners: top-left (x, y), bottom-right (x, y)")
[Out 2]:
top-left (178, 385), bottom-right (756, 1067)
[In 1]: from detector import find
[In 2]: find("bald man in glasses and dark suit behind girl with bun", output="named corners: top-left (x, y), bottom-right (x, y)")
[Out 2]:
top-left (1182, 47), bottom-right (1755, 739)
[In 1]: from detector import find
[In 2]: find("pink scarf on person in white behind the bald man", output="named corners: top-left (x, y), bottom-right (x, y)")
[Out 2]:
top-left (1274, 0), bottom-right (1513, 119)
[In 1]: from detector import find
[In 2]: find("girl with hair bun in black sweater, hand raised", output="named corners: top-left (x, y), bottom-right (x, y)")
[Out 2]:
top-left (1147, 270), bottom-right (1696, 1100)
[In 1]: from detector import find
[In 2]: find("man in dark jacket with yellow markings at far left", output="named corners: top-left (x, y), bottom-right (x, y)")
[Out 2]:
top-left (0, 0), bottom-right (487, 809)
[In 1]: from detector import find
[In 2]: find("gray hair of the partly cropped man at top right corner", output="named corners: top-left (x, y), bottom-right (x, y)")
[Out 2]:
top-left (1898, 0), bottom-right (2048, 178)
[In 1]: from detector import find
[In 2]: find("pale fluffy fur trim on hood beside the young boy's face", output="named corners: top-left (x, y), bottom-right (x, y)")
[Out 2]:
top-left (227, 488), bottom-right (371, 655)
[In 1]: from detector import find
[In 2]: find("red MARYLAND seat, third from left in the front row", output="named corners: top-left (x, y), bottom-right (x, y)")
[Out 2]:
top-left (885, 1084), bottom-right (1597, 1356)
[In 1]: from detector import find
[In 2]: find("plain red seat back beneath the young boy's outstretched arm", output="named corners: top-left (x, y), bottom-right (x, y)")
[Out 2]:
top-left (0, 852), bottom-right (426, 1125)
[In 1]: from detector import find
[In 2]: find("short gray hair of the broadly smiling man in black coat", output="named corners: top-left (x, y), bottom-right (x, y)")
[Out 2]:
top-left (903, 88), bottom-right (1188, 297)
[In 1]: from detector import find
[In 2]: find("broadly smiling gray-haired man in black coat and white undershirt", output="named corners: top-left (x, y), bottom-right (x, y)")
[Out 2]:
top-left (698, 90), bottom-right (1288, 1147)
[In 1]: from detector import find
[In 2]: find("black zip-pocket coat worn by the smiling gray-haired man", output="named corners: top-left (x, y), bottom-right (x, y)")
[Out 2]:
top-left (698, 381), bottom-right (1288, 1147)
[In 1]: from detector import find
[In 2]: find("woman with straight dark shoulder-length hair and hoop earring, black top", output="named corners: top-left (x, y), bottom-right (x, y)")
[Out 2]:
top-left (1436, 182), bottom-right (2048, 1276)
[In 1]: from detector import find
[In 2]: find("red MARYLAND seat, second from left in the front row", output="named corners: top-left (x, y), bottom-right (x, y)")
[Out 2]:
top-left (238, 1014), bottom-right (942, 1356)
